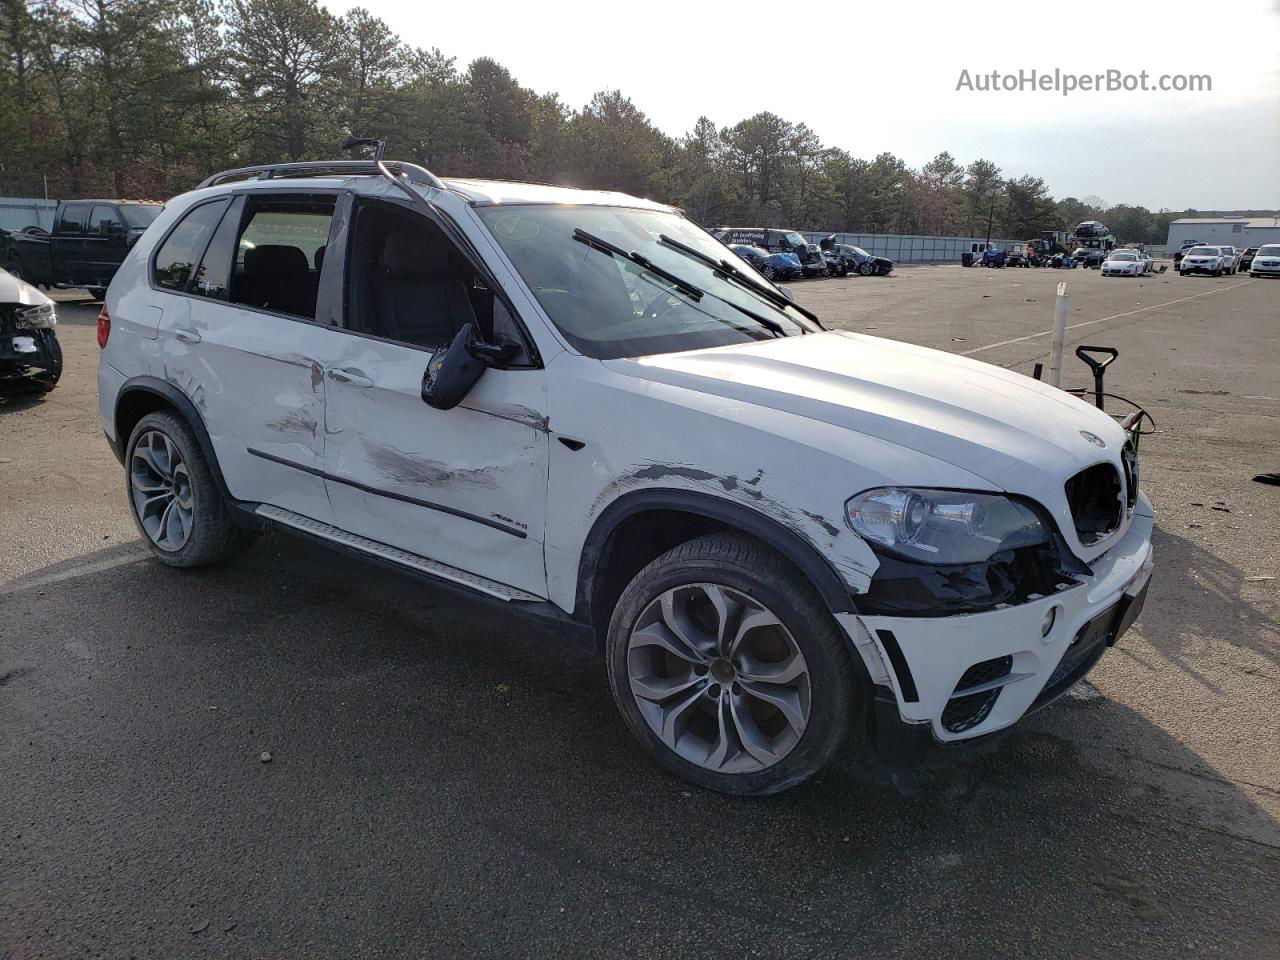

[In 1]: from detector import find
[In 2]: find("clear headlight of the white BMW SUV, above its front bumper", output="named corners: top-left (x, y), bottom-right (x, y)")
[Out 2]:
top-left (845, 486), bottom-right (1050, 564)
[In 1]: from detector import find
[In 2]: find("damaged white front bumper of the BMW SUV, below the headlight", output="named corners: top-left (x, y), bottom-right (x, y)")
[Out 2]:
top-left (837, 497), bottom-right (1155, 763)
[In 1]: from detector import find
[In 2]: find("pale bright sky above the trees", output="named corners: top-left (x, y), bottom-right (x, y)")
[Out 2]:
top-left (332, 0), bottom-right (1280, 210)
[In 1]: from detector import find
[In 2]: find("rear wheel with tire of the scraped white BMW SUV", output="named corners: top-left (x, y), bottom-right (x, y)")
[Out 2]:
top-left (124, 412), bottom-right (253, 567)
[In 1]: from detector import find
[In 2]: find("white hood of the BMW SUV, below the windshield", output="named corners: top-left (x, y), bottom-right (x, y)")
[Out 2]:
top-left (607, 332), bottom-right (1125, 496)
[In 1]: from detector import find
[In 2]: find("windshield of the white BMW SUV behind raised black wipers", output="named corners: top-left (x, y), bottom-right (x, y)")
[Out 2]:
top-left (476, 205), bottom-right (812, 360)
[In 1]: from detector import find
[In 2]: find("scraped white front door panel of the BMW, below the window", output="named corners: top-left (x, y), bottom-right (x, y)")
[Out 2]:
top-left (325, 332), bottom-right (547, 596)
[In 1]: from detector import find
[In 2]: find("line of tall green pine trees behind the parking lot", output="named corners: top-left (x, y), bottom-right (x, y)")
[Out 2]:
top-left (0, 0), bottom-right (1194, 243)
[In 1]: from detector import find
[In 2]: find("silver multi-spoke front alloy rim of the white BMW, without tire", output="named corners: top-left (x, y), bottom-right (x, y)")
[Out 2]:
top-left (627, 584), bottom-right (810, 773)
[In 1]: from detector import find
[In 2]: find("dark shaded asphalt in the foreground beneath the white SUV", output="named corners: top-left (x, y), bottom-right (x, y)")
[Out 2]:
top-left (0, 538), bottom-right (1280, 960)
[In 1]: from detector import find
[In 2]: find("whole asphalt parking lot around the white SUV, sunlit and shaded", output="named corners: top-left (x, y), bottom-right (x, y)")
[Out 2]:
top-left (0, 266), bottom-right (1280, 960)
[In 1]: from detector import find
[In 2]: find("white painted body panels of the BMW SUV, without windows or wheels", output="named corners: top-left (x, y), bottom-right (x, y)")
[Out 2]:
top-left (99, 177), bottom-right (1152, 740)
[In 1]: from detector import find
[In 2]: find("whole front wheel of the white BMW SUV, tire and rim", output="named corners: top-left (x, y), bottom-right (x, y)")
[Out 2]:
top-left (605, 534), bottom-right (859, 796)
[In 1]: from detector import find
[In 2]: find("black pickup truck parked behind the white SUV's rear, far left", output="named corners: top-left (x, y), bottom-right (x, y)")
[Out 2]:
top-left (0, 200), bottom-right (160, 298)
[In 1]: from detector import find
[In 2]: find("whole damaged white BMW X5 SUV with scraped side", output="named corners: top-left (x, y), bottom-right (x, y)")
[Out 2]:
top-left (99, 161), bottom-right (1153, 794)
